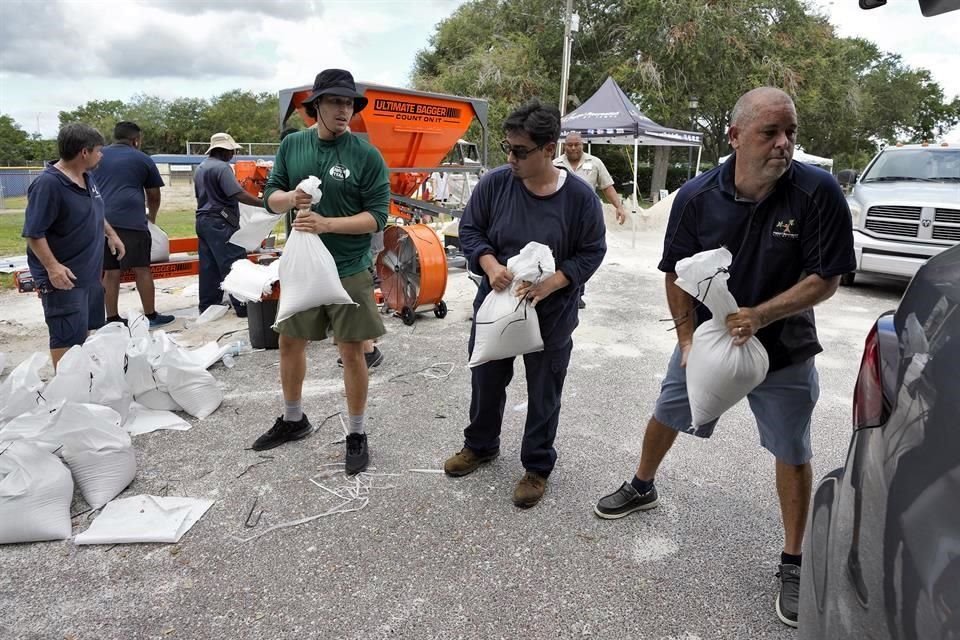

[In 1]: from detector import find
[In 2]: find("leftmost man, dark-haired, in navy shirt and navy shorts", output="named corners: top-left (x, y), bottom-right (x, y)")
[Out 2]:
top-left (22, 124), bottom-right (125, 368)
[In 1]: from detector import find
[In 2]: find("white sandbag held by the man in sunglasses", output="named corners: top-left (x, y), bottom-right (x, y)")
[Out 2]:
top-left (470, 242), bottom-right (556, 367)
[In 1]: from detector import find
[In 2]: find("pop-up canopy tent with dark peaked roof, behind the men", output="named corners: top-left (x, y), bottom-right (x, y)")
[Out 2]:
top-left (560, 77), bottom-right (703, 207)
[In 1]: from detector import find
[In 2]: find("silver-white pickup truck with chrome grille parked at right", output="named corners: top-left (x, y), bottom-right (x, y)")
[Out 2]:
top-left (841, 143), bottom-right (960, 285)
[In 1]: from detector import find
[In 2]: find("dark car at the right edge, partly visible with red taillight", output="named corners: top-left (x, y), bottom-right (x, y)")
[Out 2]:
top-left (799, 246), bottom-right (960, 640)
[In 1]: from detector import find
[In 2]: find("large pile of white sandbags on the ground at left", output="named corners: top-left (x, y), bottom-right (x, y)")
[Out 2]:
top-left (0, 315), bottom-right (232, 544)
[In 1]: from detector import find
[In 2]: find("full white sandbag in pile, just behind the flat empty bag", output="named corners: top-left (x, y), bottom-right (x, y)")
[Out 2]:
top-left (49, 402), bottom-right (137, 509)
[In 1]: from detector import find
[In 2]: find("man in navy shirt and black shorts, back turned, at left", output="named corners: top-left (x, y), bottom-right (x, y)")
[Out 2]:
top-left (93, 121), bottom-right (174, 329)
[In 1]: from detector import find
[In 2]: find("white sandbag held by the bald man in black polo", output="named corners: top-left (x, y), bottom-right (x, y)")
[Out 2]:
top-left (676, 248), bottom-right (770, 427)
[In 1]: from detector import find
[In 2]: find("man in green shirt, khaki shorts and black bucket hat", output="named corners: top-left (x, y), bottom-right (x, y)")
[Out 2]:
top-left (253, 69), bottom-right (390, 474)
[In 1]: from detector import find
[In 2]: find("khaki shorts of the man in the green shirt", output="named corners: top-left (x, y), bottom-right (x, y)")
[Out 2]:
top-left (274, 270), bottom-right (387, 342)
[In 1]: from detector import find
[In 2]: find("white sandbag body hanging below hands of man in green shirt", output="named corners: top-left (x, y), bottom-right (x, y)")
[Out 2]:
top-left (274, 229), bottom-right (356, 326)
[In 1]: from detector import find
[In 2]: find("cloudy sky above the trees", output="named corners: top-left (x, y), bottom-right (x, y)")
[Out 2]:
top-left (0, 0), bottom-right (960, 142)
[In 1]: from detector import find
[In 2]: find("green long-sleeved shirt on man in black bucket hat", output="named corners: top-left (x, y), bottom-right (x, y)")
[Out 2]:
top-left (263, 129), bottom-right (390, 278)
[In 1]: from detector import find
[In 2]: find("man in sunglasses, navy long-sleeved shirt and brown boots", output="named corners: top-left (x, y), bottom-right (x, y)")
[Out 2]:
top-left (444, 101), bottom-right (607, 508)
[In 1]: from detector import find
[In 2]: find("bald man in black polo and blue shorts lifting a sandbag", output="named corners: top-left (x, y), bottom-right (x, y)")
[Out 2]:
top-left (594, 87), bottom-right (856, 627)
